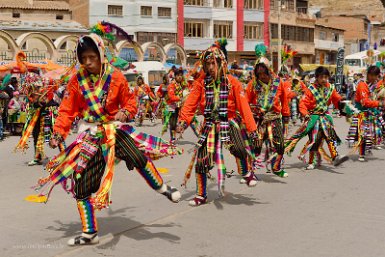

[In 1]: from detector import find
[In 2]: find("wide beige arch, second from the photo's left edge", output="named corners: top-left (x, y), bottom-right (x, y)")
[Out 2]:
top-left (16, 32), bottom-right (56, 62)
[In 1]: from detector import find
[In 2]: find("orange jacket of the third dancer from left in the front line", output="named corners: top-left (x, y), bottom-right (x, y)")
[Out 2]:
top-left (246, 78), bottom-right (290, 116)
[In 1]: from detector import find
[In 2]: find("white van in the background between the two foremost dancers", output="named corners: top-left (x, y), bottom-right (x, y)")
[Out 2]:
top-left (123, 61), bottom-right (167, 92)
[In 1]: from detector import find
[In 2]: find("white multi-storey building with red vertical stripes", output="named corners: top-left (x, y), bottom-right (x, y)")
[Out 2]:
top-left (178, 0), bottom-right (264, 63)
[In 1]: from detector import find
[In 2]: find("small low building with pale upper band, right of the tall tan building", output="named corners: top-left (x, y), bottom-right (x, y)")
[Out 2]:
top-left (314, 24), bottom-right (345, 64)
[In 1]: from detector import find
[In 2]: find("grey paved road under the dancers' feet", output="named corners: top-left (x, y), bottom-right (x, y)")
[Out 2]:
top-left (0, 116), bottom-right (385, 257)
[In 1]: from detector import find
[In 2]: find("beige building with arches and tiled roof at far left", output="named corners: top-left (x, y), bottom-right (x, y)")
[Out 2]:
top-left (0, 0), bottom-right (88, 65)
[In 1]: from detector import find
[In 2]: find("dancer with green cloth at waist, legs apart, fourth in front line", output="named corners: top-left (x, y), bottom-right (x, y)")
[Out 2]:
top-left (285, 66), bottom-right (349, 170)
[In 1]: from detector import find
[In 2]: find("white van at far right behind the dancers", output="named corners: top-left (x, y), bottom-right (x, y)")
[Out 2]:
top-left (345, 50), bottom-right (381, 75)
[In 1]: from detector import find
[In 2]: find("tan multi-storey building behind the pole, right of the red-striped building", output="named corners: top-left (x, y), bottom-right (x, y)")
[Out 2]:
top-left (270, 0), bottom-right (316, 69)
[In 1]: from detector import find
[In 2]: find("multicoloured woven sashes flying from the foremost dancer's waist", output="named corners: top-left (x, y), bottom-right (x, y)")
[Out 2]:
top-left (35, 124), bottom-right (183, 209)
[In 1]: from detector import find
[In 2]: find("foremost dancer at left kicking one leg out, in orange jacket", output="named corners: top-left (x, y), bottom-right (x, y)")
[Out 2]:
top-left (32, 34), bottom-right (181, 246)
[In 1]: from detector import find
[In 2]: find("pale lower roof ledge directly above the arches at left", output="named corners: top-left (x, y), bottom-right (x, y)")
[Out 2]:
top-left (0, 20), bottom-right (88, 33)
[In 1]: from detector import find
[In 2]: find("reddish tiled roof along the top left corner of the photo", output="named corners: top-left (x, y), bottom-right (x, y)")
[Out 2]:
top-left (0, 0), bottom-right (69, 11)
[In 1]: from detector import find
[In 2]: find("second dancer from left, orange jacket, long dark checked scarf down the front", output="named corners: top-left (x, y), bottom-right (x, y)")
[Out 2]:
top-left (177, 41), bottom-right (257, 206)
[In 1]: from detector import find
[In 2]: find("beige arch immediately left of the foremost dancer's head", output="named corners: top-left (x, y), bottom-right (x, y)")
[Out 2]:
top-left (54, 35), bottom-right (78, 66)
